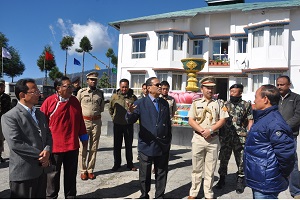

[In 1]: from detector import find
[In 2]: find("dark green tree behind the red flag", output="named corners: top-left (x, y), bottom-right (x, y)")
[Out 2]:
top-left (36, 45), bottom-right (56, 85)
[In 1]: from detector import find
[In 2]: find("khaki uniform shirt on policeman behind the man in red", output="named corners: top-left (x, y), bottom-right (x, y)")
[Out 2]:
top-left (77, 87), bottom-right (105, 117)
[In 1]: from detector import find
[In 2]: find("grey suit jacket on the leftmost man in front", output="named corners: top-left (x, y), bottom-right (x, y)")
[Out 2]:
top-left (1, 103), bottom-right (52, 181)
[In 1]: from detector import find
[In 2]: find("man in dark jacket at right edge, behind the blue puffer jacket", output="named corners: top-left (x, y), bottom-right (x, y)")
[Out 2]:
top-left (276, 76), bottom-right (300, 199)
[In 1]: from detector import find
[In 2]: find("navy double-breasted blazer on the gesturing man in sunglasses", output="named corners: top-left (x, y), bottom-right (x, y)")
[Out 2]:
top-left (126, 95), bottom-right (172, 156)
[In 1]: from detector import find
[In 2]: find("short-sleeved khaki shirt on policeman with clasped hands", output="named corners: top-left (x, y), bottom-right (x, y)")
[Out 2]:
top-left (188, 98), bottom-right (229, 129)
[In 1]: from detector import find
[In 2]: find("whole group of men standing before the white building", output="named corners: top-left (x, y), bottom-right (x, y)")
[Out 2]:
top-left (0, 72), bottom-right (300, 199)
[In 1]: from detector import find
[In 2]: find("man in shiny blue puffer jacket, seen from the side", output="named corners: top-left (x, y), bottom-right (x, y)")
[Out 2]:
top-left (244, 85), bottom-right (295, 199)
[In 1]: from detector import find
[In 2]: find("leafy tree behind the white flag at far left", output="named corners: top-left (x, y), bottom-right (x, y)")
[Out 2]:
top-left (3, 47), bottom-right (25, 82)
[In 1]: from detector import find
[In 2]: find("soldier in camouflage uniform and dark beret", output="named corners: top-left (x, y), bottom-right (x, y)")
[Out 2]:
top-left (216, 84), bottom-right (253, 194)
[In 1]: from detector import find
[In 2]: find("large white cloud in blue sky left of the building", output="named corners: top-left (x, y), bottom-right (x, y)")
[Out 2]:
top-left (57, 18), bottom-right (113, 55)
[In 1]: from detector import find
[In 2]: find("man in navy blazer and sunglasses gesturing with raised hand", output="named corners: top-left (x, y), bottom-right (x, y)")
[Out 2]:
top-left (126, 77), bottom-right (172, 199)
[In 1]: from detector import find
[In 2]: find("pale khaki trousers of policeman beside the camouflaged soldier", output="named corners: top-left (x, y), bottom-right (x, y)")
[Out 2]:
top-left (189, 133), bottom-right (220, 198)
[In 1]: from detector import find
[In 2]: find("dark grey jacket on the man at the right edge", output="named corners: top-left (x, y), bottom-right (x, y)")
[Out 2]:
top-left (278, 91), bottom-right (300, 136)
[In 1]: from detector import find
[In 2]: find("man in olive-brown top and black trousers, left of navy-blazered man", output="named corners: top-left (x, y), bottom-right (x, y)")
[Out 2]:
top-left (109, 79), bottom-right (137, 171)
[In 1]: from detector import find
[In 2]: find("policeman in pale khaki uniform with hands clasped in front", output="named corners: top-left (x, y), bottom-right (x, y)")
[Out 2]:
top-left (188, 76), bottom-right (228, 199)
